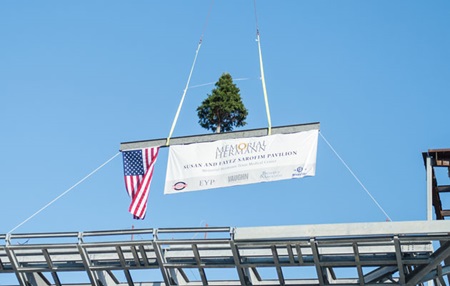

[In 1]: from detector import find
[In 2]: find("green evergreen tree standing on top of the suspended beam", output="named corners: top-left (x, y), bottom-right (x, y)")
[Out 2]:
top-left (197, 73), bottom-right (248, 133)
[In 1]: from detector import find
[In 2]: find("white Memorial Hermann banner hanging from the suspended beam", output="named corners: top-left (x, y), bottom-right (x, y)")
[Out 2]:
top-left (164, 130), bottom-right (319, 194)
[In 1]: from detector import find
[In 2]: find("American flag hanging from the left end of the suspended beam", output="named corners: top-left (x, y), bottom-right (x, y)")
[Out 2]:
top-left (122, 147), bottom-right (159, 219)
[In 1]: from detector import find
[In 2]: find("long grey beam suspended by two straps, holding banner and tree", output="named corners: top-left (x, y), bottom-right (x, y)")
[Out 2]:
top-left (120, 122), bottom-right (320, 151)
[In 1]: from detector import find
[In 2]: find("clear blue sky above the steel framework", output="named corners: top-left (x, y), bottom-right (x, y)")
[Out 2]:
top-left (0, 0), bottom-right (450, 236)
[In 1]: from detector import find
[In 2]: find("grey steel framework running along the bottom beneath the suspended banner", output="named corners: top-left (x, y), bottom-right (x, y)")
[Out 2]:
top-left (0, 220), bottom-right (450, 286)
